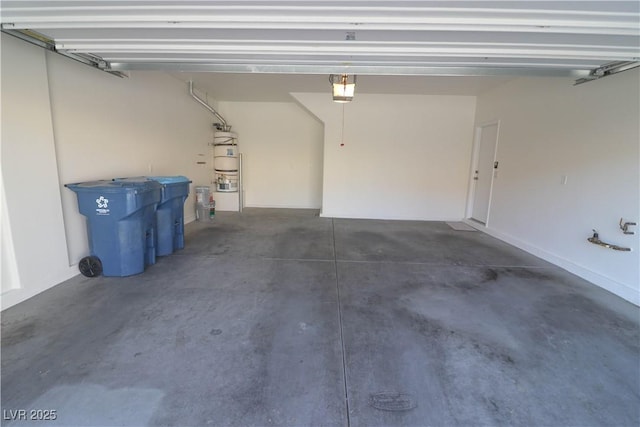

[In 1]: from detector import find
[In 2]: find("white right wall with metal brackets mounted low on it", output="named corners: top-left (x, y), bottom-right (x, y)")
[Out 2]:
top-left (476, 70), bottom-right (640, 304)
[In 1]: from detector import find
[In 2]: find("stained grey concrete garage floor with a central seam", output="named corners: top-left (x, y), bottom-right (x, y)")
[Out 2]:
top-left (2, 210), bottom-right (640, 426)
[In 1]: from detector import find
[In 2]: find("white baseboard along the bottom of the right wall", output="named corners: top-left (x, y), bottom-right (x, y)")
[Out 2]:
top-left (463, 219), bottom-right (640, 306)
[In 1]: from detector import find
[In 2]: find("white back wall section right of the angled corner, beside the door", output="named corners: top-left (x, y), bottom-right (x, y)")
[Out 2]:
top-left (292, 93), bottom-right (475, 220)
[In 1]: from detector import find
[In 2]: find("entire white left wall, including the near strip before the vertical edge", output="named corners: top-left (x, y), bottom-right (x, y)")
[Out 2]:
top-left (2, 35), bottom-right (214, 308)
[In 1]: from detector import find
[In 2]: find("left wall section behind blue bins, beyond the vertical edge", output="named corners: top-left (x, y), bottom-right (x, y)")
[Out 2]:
top-left (47, 54), bottom-right (214, 264)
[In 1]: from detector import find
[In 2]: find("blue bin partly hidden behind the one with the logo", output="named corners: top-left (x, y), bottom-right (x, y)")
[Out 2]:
top-left (147, 176), bottom-right (191, 256)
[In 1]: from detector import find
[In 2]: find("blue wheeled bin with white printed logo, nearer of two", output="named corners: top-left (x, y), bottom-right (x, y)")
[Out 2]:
top-left (65, 180), bottom-right (161, 277)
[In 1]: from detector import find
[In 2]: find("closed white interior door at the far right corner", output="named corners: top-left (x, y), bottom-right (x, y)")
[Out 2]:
top-left (471, 123), bottom-right (498, 224)
